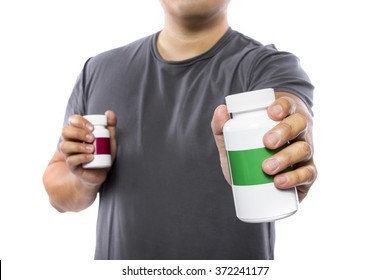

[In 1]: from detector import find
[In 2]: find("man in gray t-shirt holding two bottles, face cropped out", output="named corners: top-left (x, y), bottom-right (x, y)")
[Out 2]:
top-left (43, 0), bottom-right (316, 259)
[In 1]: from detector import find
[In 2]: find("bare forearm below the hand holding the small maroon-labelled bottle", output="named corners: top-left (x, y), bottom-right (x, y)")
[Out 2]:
top-left (43, 161), bottom-right (99, 212)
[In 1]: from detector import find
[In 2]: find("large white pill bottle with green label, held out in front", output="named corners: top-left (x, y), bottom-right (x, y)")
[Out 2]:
top-left (223, 88), bottom-right (299, 223)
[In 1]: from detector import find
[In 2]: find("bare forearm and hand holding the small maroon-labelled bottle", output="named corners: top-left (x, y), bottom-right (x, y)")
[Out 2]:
top-left (43, 111), bottom-right (116, 212)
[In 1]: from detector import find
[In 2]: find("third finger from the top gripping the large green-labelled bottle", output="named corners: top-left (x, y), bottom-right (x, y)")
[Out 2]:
top-left (262, 141), bottom-right (313, 175)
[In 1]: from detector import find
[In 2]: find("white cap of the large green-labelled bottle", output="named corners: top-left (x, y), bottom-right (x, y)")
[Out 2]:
top-left (225, 88), bottom-right (275, 113)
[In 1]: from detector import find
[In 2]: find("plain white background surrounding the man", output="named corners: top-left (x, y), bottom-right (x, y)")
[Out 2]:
top-left (0, 0), bottom-right (390, 279)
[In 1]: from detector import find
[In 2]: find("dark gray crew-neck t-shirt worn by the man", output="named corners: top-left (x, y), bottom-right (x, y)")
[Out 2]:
top-left (65, 29), bottom-right (313, 259)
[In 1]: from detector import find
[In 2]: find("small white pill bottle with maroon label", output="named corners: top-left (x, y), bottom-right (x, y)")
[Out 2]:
top-left (83, 115), bottom-right (111, 168)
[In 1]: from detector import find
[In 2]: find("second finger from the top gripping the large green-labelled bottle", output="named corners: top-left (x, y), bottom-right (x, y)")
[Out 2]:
top-left (263, 113), bottom-right (307, 150)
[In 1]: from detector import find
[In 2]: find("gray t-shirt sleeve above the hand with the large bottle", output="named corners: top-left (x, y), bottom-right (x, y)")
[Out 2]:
top-left (249, 45), bottom-right (314, 113)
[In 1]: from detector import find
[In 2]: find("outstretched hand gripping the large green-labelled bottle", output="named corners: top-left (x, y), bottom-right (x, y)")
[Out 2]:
top-left (211, 92), bottom-right (317, 201)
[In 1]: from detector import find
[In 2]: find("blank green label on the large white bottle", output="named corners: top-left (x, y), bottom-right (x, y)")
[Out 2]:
top-left (228, 148), bottom-right (277, 186)
